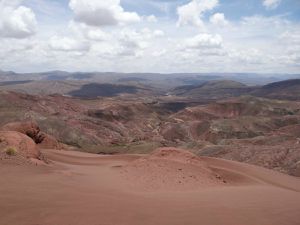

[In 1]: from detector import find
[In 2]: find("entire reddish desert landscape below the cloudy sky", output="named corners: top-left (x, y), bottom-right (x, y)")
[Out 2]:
top-left (0, 72), bottom-right (300, 225)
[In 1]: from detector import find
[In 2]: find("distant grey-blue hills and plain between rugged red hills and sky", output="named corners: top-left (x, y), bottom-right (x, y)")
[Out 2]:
top-left (0, 71), bottom-right (300, 101)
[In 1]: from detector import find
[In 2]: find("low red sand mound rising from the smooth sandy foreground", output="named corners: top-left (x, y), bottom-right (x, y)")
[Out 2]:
top-left (120, 148), bottom-right (226, 191)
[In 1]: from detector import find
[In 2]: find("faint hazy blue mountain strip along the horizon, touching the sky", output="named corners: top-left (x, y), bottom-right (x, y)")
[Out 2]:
top-left (0, 70), bottom-right (300, 87)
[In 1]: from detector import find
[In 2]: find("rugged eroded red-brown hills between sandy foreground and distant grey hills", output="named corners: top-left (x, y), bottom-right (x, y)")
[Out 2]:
top-left (0, 91), bottom-right (300, 176)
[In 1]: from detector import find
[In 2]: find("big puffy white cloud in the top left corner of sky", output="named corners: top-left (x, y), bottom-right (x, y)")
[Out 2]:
top-left (0, 1), bottom-right (37, 39)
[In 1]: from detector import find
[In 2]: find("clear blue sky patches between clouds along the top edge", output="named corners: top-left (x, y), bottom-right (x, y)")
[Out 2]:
top-left (24, 0), bottom-right (300, 24)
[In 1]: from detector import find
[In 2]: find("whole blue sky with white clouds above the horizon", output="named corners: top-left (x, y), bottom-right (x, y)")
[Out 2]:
top-left (0, 0), bottom-right (300, 73)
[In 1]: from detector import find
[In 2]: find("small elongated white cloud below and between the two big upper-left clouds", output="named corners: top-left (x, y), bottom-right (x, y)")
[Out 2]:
top-left (49, 36), bottom-right (90, 52)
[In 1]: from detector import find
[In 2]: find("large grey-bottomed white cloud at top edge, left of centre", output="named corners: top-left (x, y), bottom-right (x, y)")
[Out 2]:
top-left (69, 0), bottom-right (141, 26)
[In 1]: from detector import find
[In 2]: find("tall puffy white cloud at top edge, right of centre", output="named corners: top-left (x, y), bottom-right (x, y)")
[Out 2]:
top-left (177, 0), bottom-right (219, 27)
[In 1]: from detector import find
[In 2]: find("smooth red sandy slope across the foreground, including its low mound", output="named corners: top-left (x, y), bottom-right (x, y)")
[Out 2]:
top-left (0, 150), bottom-right (300, 225)
